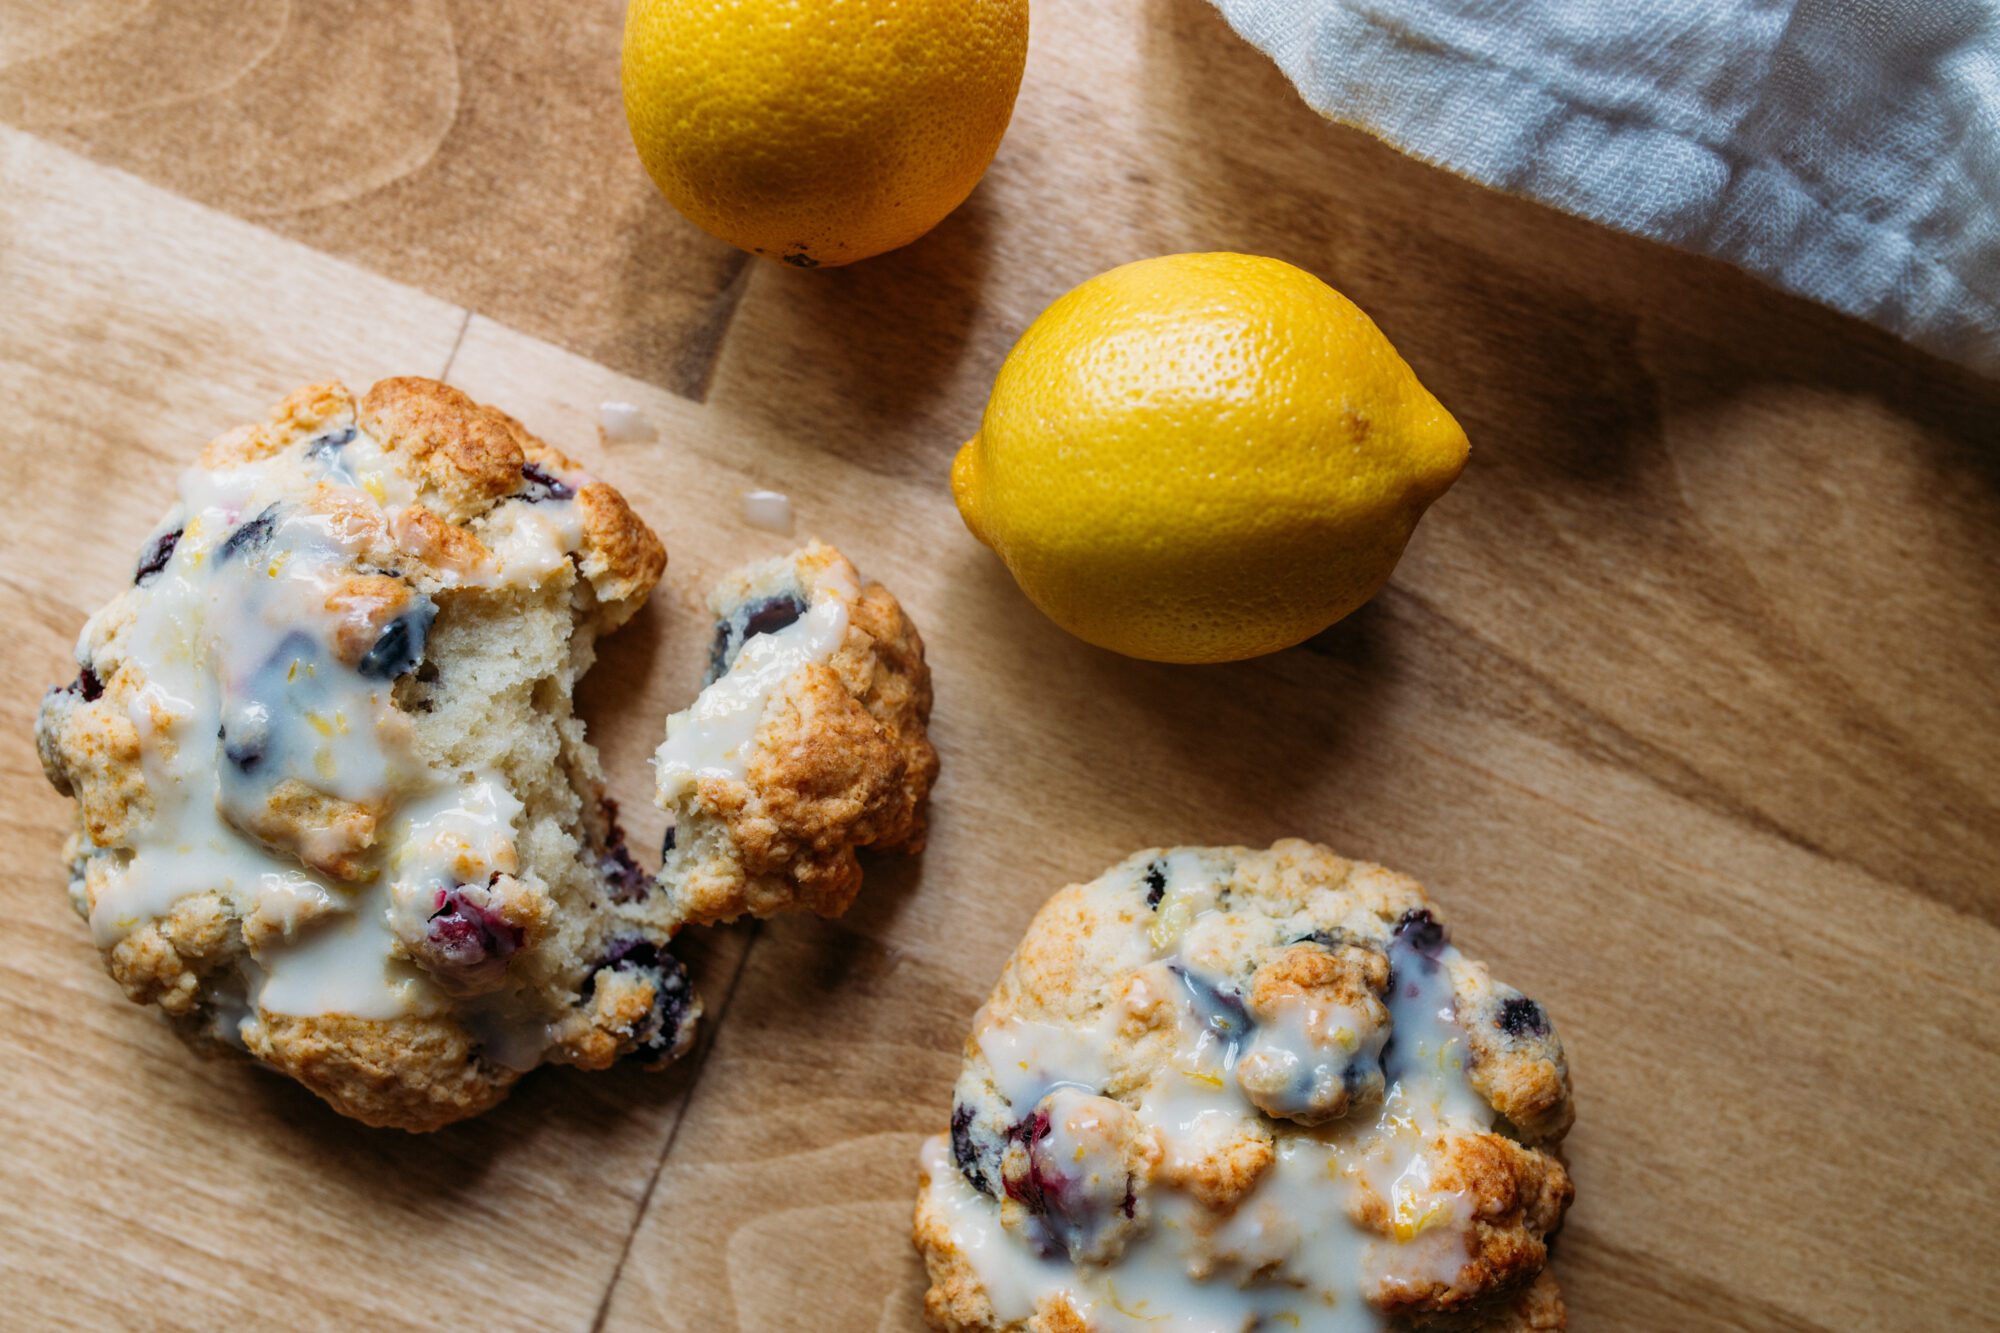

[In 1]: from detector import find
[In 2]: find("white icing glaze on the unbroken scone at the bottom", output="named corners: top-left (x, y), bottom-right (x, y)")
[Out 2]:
top-left (924, 857), bottom-right (1494, 1333)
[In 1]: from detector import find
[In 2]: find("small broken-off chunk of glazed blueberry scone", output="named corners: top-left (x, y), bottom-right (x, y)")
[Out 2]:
top-left (654, 542), bottom-right (938, 923)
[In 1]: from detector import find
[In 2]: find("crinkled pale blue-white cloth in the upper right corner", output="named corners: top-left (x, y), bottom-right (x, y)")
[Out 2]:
top-left (1214, 0), bottom-right (2000, 374)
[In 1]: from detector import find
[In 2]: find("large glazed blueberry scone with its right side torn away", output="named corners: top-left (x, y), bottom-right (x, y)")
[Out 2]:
top-left (36, 378), bottom-right (700, 1129)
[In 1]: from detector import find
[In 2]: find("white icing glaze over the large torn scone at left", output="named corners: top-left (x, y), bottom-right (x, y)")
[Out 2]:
top-left (80, 420), bottom-right (588, 1039)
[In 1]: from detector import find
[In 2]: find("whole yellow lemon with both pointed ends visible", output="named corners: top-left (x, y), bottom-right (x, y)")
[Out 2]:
top-left (952, 254), bottom-right (1468, 662)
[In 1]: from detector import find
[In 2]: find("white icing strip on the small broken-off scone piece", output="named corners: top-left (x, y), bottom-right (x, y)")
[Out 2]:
top-left (654, 570), bottom-right (856, 801)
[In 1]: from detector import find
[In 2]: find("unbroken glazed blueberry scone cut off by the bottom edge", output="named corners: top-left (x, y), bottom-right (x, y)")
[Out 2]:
top-left (916, 841), bottom-right (1572, 1333)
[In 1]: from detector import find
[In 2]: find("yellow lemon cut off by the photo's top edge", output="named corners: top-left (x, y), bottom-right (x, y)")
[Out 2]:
top-left (624, 0), bottom-right (1028, 268)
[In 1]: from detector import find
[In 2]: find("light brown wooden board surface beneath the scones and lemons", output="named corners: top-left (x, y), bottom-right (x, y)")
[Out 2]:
top-left (0, 0), bottom-right (2000, 1331)
